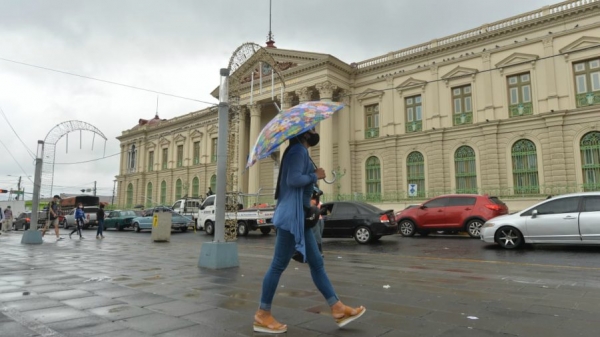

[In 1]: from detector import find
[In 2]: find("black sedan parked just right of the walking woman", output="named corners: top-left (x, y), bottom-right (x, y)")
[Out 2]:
top-left (321, 201), bottom-right (398, 244)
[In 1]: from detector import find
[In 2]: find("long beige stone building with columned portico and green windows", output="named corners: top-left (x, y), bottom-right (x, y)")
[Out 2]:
top-left (117, 0), bottom-right (600, 208)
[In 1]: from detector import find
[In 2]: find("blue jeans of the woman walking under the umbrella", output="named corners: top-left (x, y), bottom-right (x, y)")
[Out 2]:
top-left (260, 229), bottom-right (339, 311)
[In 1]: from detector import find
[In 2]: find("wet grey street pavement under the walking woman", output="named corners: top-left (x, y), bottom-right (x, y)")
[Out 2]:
top-left (0, 230), bottom-right (600, 337)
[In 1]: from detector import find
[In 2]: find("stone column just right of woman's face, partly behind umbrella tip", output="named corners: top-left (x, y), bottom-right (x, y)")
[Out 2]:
top-left (315, 81), bottom-right (337, 197)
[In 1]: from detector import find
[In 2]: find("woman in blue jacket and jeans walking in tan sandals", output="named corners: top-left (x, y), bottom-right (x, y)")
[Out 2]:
top-left (254, 129), bottom-right (366, 333)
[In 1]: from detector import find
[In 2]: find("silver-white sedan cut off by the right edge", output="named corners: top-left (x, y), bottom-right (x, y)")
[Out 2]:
top-left (481, 192), bottom-right (600, 249)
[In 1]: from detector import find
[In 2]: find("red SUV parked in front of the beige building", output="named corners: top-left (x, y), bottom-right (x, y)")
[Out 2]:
top-left (398, 194), bottom-right (508, 238)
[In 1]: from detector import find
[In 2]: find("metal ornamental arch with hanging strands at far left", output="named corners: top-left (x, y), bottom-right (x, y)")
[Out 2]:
top-left (41, 120), bottom-right (107, 197)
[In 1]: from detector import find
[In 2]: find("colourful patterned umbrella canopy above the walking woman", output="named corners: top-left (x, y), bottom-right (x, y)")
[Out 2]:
top-left (246, 101), bottom-right (344, 168)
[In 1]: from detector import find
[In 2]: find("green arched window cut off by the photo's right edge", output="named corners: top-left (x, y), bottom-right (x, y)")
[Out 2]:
top-left (579, 131), bottom-right (600, 192)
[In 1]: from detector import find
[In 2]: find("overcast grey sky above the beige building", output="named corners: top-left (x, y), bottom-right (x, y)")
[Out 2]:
top-left (0, 0), bottom-right (557, 200)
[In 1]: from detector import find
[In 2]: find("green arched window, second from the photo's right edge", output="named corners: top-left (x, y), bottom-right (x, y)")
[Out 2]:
top-left (511, 139), bottom-right (540, 194)
